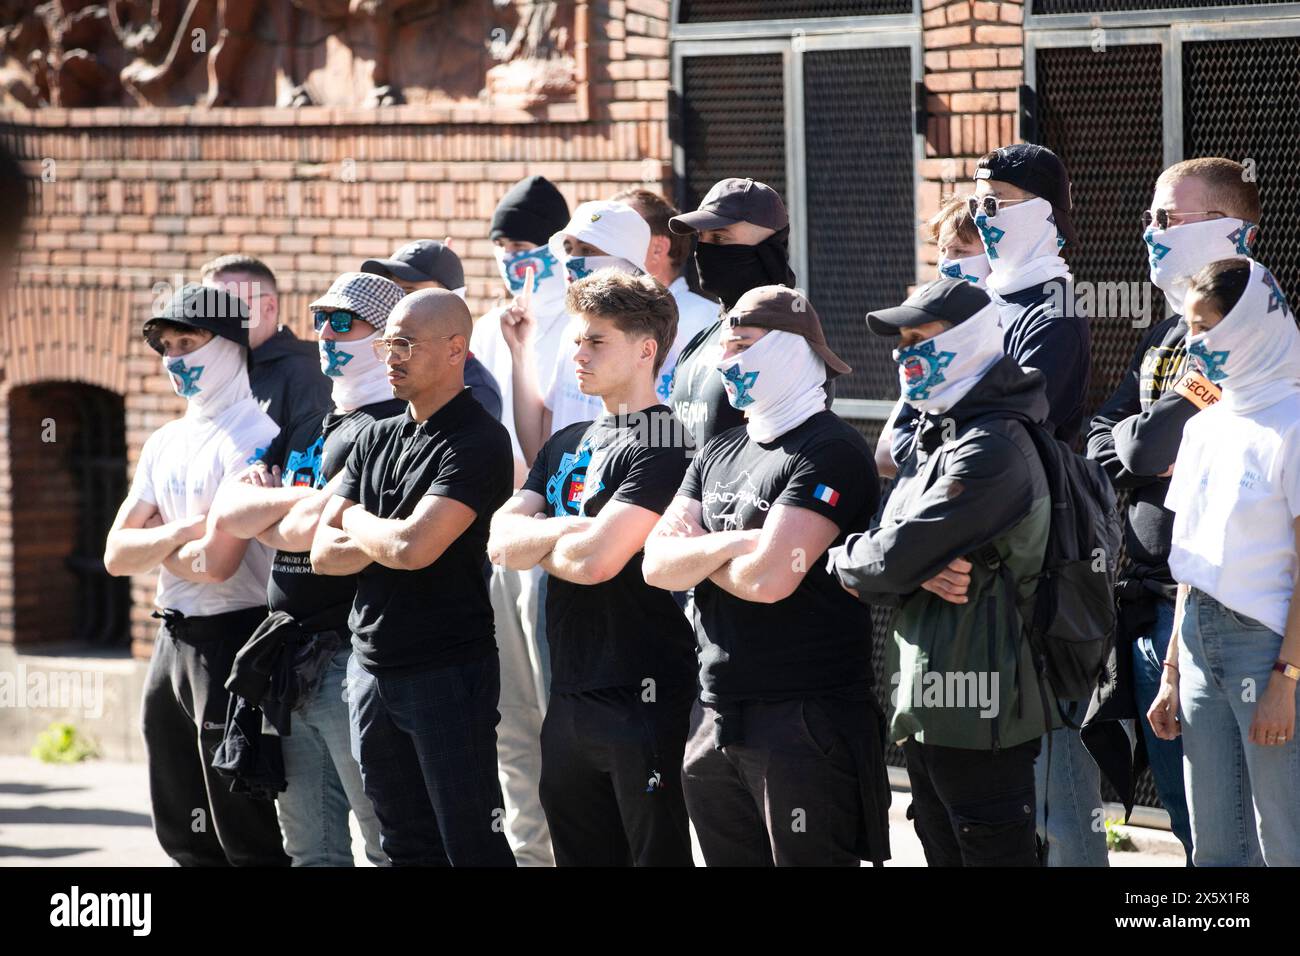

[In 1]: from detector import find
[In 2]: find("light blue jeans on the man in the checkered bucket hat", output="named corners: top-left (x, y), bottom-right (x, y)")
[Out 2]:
top-left (276, 646), bottom-right (389, 866)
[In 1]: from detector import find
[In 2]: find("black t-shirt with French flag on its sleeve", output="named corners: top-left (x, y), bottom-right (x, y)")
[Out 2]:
top-left (680, 411), bottom-right (880, 704)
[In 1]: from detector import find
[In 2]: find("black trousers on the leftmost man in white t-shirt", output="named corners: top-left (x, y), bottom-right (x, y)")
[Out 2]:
top-left (140, 607), bottom-right (290, 866)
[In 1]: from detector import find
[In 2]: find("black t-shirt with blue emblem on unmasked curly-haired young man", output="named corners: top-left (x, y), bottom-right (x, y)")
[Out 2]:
top-left (524, 405), bottom-right (696, 695)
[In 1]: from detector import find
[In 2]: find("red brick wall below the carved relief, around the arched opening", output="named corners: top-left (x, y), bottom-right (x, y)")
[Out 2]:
top-left (0, 0), bottom-right (671, 654)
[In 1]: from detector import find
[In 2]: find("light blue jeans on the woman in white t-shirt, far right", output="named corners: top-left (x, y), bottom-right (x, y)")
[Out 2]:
top-left (1178, 588), bottom-right (1300, 866)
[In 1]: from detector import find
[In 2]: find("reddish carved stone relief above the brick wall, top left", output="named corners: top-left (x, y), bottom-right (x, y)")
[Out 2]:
top-left (0, 0), bottom-right (585, 109)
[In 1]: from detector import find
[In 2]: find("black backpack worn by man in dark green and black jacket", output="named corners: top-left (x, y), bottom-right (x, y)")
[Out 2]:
top-left (1024, 421), bottom-right (1123, 700)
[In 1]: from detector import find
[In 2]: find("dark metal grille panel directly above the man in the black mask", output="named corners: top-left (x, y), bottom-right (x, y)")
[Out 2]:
top-left (680, 53), bottom-right (785, 209)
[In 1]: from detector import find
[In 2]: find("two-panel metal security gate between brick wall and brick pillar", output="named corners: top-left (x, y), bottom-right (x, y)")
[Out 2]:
top-left (670, 7), bottom-right (923, 421)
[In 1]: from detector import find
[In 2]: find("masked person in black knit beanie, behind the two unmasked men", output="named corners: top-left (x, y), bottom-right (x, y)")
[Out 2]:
top-left (469, 176), bottom-right (569, 866)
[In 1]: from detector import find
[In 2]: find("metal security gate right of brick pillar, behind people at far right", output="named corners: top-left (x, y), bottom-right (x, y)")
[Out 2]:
top-left (1022, 0), bottom-right (1300, 808)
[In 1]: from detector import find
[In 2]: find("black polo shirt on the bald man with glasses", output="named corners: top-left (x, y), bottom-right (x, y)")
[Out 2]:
top-left (338, 389), bottom-right (515, 674)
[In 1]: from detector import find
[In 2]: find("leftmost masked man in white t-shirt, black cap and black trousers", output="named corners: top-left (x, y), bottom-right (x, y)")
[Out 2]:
top-left (104, 285), bottom-right (289, 866)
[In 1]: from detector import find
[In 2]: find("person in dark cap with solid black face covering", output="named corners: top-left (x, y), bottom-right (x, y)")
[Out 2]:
top-left (668, 179), bottom-right (794, 449)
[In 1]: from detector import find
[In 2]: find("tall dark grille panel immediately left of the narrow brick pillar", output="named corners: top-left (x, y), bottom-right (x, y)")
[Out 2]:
top-left (801, 47), bottom-right (917, 399)
